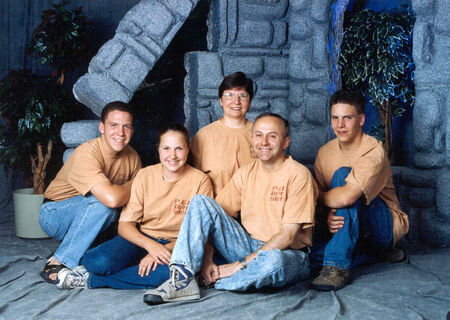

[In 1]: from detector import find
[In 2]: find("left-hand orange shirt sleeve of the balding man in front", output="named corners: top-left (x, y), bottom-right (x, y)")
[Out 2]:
top-left (216, 168), bottom-right (244, 218)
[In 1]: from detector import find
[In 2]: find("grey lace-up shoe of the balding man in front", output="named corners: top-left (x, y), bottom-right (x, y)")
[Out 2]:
top-left (144, 265), bottom-right (200, 305)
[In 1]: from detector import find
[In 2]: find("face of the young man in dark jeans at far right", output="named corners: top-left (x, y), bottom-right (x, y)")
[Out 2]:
top-left (331, 103), bottom-right (366, 148)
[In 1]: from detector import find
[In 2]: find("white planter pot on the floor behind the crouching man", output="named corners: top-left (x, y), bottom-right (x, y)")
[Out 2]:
top-left (13, 188), bottom-right (49, 239)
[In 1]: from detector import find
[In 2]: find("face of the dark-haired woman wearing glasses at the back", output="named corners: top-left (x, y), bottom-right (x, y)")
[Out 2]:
top-left (219, 87), bottom-right (251, 119)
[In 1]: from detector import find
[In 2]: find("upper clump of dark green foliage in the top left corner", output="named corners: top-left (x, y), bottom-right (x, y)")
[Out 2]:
top-left (28, 1), bottom-right (90, 84)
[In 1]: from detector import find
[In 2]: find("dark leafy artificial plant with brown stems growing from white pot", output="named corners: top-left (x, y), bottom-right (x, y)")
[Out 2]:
top-left (0, 69), bottom-right (73, 193)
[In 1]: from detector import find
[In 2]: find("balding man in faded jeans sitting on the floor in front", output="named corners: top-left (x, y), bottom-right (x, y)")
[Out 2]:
top-left (144, 113), bottom-right (318, 305)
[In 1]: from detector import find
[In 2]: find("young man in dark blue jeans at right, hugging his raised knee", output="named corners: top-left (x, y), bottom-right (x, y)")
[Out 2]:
top-left (311, 91), bottom-right (408, 290)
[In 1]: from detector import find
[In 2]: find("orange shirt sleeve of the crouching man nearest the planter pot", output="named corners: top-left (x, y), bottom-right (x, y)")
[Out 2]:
top-left (67, 150), bottom-right (110, 196)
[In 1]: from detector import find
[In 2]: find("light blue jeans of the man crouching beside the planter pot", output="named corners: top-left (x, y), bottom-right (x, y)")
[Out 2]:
top-left (39, 195), bottom-right (118, 269)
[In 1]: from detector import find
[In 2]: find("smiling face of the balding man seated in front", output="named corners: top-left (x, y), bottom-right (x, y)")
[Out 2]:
top-left (253, 116), bottom-right (290, 170)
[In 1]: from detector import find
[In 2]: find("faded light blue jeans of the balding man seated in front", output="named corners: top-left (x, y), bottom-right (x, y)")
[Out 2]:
top-left (170, 195), bottom-right (310, 291)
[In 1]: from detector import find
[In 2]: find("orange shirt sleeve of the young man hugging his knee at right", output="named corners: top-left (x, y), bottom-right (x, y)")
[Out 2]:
top-left (345, 146), bottom-right (390, 204)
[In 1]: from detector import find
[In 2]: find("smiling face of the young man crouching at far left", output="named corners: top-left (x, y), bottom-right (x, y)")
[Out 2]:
top-left (98, 110), bottom-right (134, 152)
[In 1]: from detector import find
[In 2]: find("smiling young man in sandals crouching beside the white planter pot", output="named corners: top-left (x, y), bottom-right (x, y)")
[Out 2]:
top-left (39, 101), bottom-right (141, 284)
